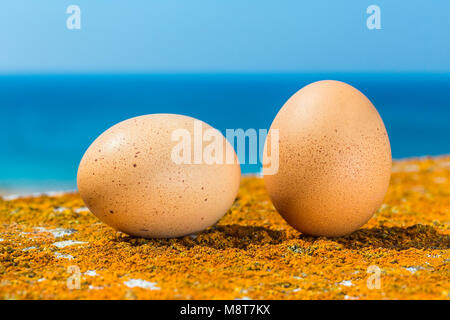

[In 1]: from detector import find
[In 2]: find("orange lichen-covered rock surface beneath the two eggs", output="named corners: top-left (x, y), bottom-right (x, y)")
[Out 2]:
top-left (0, 157), bottom-right (450, 299)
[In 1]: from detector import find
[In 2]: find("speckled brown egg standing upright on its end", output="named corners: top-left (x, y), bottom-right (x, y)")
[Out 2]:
top-left (263, 80), bottom-right (392, 237)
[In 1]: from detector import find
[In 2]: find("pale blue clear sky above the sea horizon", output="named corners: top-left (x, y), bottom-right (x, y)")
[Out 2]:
top-left (0, 0), bottom-right (450, 74)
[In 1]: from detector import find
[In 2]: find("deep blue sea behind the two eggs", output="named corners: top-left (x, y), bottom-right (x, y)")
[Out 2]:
top-left (0, 73), bottom-right (450, 193)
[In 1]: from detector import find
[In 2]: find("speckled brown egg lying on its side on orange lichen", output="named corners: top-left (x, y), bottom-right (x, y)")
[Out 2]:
top-left (78, 114), bottom-right (241, 238)
